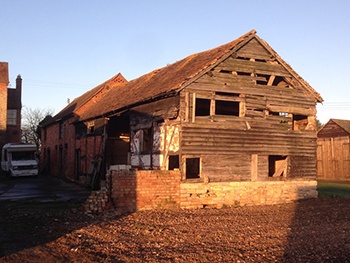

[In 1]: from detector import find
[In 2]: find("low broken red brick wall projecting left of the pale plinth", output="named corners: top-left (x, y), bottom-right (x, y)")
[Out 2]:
top-left (107, 170), bottom-right (181, 213)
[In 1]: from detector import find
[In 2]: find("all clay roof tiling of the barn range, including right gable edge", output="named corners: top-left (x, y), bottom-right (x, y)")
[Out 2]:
top-left (47, 30), bottom-right (322, 125)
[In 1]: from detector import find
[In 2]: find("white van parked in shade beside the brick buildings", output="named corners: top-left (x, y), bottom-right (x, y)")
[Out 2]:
top-left (1, 143), bottom-right (38, 177)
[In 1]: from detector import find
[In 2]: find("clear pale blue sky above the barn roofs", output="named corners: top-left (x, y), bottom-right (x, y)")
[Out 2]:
top-left (0, 0), bottom-right (350, 123)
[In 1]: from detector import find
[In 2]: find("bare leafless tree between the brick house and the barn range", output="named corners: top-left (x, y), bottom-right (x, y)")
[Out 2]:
top-left (22, 106), bottom-right (54, 149)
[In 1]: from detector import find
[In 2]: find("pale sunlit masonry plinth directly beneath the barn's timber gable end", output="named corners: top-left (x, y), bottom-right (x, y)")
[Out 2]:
top-left (180, 180), bottom-right (317, 208)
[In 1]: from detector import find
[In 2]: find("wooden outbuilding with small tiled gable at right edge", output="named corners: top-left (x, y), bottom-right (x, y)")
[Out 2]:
top-left (317, 119), bottom-right (350, 181)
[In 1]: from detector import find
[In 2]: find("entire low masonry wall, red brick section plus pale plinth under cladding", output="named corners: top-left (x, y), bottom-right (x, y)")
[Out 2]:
top-left (107, 170), bottom-right (317, 212)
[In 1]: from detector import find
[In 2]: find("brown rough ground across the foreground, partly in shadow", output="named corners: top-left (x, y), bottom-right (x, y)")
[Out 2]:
top-left (0, 198), bottom-right (350, 262)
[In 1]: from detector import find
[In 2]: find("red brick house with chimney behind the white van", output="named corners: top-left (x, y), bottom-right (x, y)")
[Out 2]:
top-left (0, 62), bottom-right (22, 151)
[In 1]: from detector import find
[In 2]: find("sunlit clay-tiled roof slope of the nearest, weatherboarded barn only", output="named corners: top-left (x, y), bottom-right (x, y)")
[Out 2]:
top-left (80, 30), bottom-right (256, 120)
